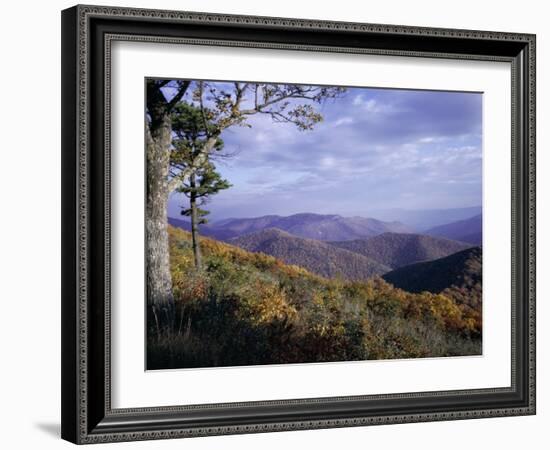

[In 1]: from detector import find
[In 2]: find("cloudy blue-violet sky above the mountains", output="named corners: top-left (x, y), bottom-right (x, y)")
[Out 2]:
top-left (165, 81), bottom-right (482, 220)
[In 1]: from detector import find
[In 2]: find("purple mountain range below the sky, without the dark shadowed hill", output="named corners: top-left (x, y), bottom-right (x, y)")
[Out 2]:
top-left (169, 213), bottom-right (482, 284)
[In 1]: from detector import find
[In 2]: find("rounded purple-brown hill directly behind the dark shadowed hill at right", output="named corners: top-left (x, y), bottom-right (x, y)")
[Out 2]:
top-left (330, 233), bottom-right (472, 269)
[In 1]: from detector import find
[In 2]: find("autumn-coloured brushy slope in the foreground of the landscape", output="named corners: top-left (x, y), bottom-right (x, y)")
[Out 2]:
top-left (147, 227), bottom-right (481, 369)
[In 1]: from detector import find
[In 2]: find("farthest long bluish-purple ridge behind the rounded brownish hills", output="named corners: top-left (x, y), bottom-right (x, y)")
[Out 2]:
top-left (168, 213), bottom-right (412, 241)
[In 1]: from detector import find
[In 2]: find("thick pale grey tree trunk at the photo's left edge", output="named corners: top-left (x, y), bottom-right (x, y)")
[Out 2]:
top-left (145, 114), bottom-right (175, 333)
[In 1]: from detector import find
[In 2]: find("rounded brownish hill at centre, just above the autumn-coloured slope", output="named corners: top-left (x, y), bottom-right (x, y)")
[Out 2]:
top-left (228, 228), bottom-right (391, 280)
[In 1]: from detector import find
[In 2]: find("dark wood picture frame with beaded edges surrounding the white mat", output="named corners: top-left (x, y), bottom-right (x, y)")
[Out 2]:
top-left (62, 6), bottom-right (535, 444)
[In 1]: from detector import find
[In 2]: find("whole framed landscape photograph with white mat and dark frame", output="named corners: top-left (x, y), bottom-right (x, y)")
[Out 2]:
top-left (62, 6), bottom-right (535, 444)
